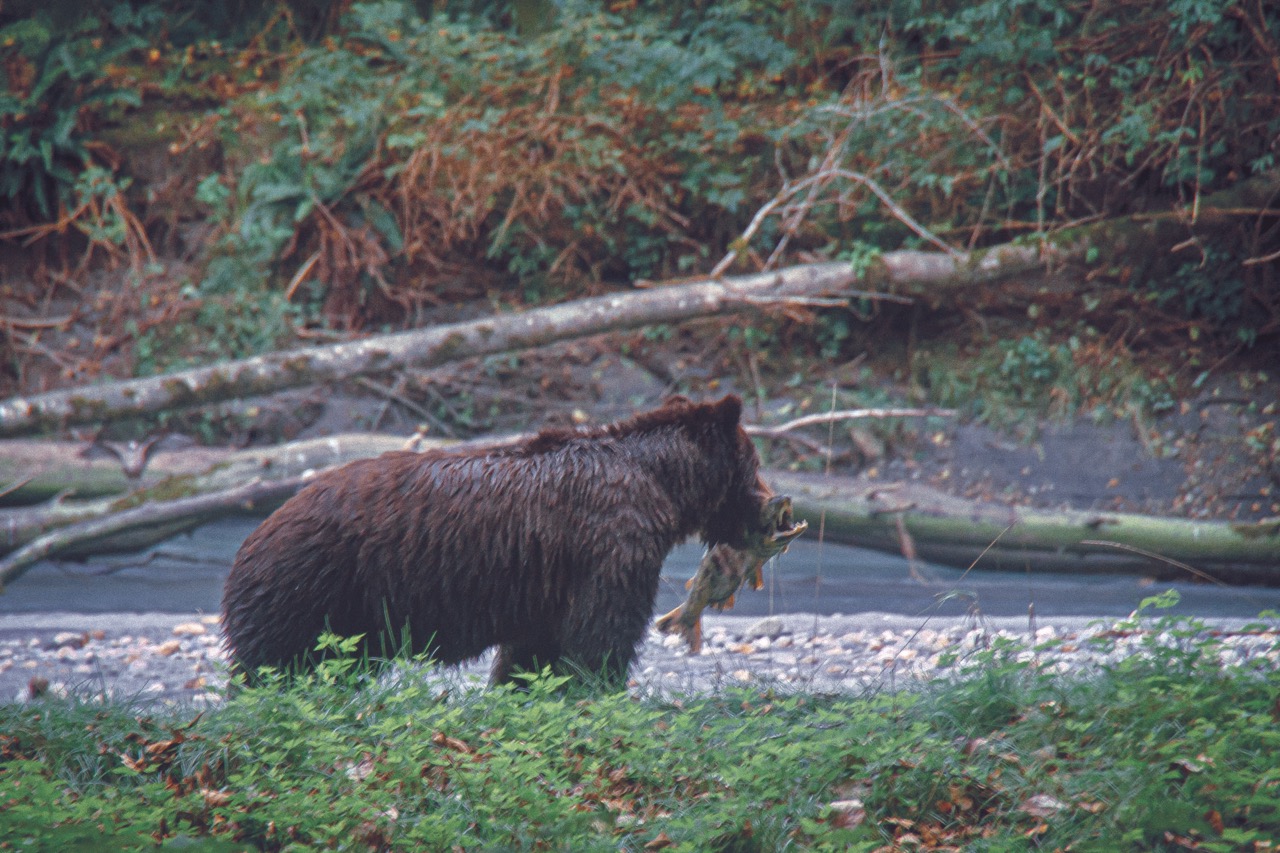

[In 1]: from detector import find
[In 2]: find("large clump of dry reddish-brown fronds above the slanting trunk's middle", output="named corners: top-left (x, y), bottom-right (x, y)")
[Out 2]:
top-left (293, 69), bottom-right (689, 325)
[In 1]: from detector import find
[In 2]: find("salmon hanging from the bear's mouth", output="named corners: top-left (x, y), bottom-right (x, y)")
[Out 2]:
top-left (654, 494), bottom-right (809, 654)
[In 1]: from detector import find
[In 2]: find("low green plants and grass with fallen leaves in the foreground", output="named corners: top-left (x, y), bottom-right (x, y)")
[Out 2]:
top-left (0, 620), bottom-right (1280, 850)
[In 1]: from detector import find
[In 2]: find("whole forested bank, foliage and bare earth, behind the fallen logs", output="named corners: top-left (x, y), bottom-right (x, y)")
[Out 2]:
top-left (0, 0), bottom-right (1280, 571)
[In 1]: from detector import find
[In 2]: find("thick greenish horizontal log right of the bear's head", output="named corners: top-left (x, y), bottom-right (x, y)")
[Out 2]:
top-left (767, 471), bottom-right (1280, 584)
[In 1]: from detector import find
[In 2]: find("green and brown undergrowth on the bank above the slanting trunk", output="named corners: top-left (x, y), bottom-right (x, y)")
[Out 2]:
top-left (0, 0), bottom-right (1280, 333)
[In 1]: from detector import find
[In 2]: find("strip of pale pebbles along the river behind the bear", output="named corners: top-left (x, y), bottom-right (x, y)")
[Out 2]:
top-left (0, 615), bottom-right (1280, 706)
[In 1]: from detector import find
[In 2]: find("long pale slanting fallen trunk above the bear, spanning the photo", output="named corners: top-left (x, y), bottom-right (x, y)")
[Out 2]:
top-left (10, 163), bottom-right (1280, 438)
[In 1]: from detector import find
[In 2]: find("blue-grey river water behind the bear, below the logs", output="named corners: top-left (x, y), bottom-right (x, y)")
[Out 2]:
top-left (0, 519), bottom-right (1280, 622)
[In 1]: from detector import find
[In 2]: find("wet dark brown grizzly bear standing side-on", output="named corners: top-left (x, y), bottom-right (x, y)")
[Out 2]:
top-left (223, 396), bottom-right (771, 684)
